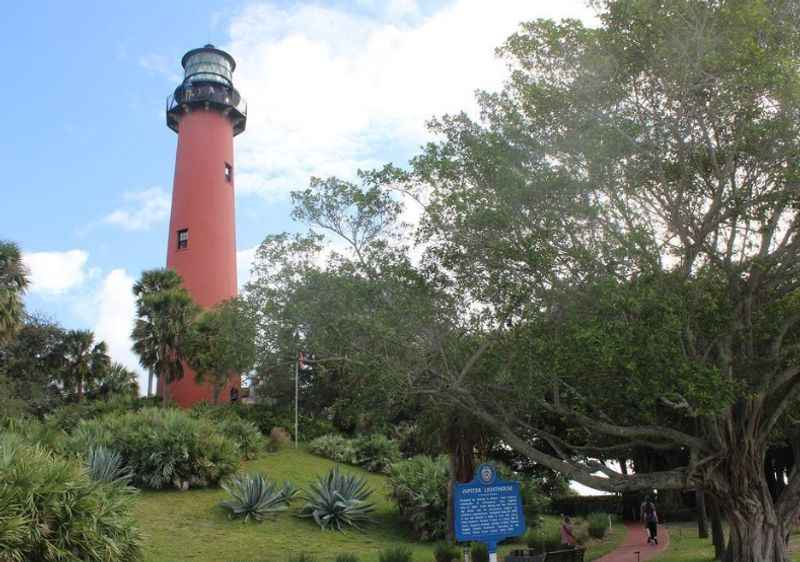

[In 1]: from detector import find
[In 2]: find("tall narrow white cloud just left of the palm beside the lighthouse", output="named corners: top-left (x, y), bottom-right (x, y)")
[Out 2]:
top-left (93, 269), bottom-right (147, 392)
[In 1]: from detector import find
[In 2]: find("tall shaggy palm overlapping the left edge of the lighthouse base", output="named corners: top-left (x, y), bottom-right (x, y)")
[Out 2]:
top-left (131, 269), bottom-right (198, 405)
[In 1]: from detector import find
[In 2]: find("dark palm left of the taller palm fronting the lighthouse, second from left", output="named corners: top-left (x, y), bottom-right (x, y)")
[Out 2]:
top-left (61, 330), bottom-right (111, 401)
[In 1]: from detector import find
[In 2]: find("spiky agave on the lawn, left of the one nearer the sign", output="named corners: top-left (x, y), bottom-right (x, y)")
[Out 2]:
top-left (220, 473), bottom-right (298, 521)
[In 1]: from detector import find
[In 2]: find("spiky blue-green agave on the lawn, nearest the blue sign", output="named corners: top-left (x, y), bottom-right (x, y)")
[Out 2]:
top-left (299, 466), bottom-right (375, 531)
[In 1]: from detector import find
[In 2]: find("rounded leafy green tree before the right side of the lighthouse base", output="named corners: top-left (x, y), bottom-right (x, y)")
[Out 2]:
top-left (186, 298), bottom-right (256, 404)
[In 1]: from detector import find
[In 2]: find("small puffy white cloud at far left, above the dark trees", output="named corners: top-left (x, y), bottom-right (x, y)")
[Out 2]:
top-left (23, 250), bottom-right (94, 295)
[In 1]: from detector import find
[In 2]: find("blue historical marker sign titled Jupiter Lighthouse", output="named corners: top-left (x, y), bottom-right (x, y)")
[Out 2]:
top-left (453, 464), bottom-right (525, 553)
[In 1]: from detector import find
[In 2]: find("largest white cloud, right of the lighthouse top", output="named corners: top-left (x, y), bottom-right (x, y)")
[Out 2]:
top-left (222, 0), bottom-right (592, 197)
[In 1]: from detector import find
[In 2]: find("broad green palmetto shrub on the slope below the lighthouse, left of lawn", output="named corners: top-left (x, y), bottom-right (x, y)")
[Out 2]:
top-left (66, 408), bottom-right (240, 489)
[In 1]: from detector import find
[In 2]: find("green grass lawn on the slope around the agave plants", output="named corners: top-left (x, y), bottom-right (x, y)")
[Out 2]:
top-left (136, 449), bottom-right (623, 562)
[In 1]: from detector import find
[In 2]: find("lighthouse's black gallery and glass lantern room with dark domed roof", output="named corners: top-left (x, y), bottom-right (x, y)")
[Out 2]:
top-left (166, 45), bottom-right (247, 136)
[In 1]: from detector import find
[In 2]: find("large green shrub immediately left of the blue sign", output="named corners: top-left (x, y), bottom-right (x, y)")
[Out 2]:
top-left (389, 456), bottom-right (450, 541)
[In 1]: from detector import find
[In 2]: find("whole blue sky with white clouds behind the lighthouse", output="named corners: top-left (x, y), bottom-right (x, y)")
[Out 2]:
top-left (0, 0), bottom-right (589, 392)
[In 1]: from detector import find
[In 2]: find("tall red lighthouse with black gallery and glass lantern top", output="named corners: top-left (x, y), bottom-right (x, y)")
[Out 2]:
top-left (159, 45), bottom-right (247, 407)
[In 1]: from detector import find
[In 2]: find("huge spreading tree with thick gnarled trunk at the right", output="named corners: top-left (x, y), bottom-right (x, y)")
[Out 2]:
top-left (376, 0), bottom-right (800, 561)
